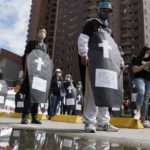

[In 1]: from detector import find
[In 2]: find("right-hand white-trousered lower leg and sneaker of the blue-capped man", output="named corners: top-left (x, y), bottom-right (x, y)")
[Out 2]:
top-left (97, 107), bottom-right (119, 132)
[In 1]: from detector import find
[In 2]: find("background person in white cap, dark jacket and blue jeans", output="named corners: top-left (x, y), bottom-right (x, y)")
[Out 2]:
top-left (48, 68), bottom-right (64, 120)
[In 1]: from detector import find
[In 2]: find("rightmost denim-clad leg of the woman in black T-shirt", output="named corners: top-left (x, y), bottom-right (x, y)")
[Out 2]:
top-left (141, 80), bottom-right (150, 123)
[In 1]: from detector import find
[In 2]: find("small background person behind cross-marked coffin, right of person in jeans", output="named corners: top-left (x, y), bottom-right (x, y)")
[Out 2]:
top-left (63, 74), bottom-right (76, 115)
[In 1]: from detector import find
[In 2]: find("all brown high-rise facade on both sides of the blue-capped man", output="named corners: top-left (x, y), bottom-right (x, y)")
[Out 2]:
top-left (28, 0), bottom-right (150, 81)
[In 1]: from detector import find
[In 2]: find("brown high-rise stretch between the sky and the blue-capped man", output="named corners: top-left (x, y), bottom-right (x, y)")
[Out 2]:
top-left (28, 0), bottom-right (98, 81)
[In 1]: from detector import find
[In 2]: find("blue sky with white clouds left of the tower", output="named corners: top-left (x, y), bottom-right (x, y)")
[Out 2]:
top-left (0, 0), bottom-right (32, 56)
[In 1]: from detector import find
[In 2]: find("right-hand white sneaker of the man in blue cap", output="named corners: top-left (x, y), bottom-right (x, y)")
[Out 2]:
top-left (96, 123), bottom-right (119, 132)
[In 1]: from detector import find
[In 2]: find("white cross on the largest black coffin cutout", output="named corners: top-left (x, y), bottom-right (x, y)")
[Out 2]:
top-left (98, 40), bottom-right (112, 58)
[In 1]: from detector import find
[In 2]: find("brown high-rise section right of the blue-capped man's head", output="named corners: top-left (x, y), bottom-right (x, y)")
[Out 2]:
top-left (110, 0), bottom-right (150, 63)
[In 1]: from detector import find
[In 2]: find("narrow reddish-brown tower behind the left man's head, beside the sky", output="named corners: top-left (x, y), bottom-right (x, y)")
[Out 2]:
top-left (27, 0), bottom-right (59, 57)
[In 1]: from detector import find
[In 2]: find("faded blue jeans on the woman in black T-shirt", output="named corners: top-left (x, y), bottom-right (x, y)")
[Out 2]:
top-left (133, 78), bottom-right (150, 117)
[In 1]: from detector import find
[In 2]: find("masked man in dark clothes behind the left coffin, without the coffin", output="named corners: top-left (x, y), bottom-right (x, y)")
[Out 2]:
top-left (20, 27), bottom-right (49, 124)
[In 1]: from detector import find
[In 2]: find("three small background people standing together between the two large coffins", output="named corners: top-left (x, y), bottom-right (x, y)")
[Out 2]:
top-left (48, 68), bottom-right (83, 119)
